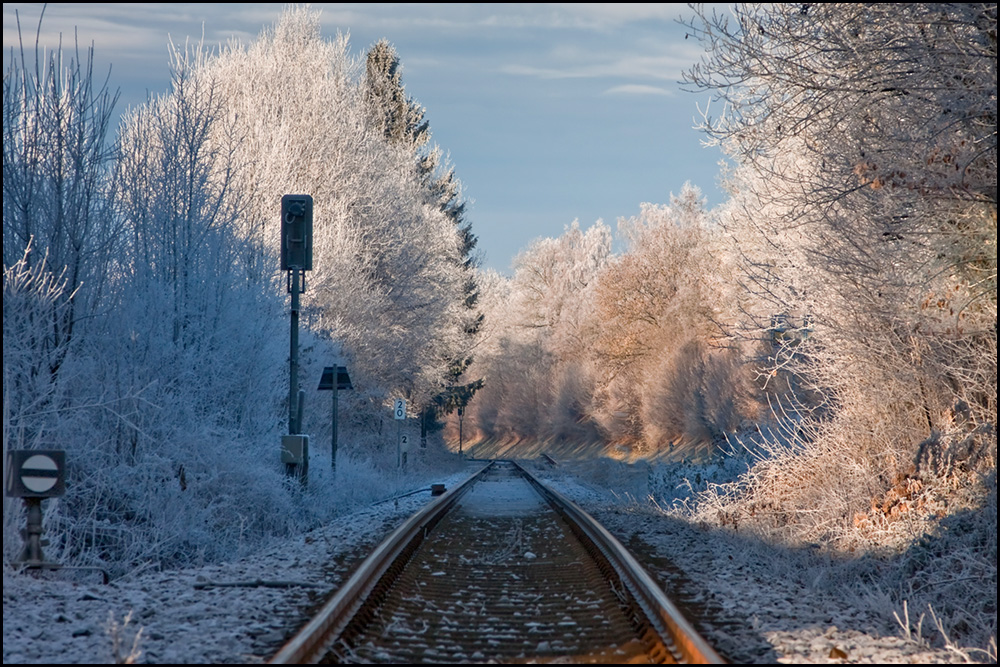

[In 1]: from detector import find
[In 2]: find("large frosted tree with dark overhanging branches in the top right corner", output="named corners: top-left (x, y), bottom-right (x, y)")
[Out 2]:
top-left (690, 3), bottom-right (996, 437)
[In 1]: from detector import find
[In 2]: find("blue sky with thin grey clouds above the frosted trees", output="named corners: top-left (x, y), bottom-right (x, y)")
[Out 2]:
top-left (3, 3), bottom-right (724, 273)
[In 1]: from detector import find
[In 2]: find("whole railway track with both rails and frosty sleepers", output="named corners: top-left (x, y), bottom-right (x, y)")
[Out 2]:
top-left (271, 461), bottom-right (723, 664)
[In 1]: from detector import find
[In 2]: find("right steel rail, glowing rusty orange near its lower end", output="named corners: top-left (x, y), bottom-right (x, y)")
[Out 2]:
top-left (514, 462), bottom-right (725, 664)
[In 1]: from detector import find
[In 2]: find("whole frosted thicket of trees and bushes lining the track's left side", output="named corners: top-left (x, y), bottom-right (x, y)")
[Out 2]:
top-left (3, 9), bottom-right (469, 576)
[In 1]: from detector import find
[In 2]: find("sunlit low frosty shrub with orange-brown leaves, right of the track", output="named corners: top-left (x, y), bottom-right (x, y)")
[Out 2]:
top-left (698, 386), bottom-right (996, 552)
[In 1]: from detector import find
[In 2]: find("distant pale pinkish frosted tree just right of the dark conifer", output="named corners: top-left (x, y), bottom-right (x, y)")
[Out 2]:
top-left (472, 221), bottom-right (611, 439)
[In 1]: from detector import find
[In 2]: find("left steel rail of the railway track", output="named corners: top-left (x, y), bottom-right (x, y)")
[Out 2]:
top-left (268, 461), bottom-right (493, 665)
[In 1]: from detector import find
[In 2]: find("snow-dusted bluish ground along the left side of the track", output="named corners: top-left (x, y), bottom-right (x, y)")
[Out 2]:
top-left (3, 464), bottom-right (481, 664)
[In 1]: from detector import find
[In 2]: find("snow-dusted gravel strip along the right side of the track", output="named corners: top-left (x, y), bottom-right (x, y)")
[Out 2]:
top-left (533, 461), bottom-right (967, 664)
